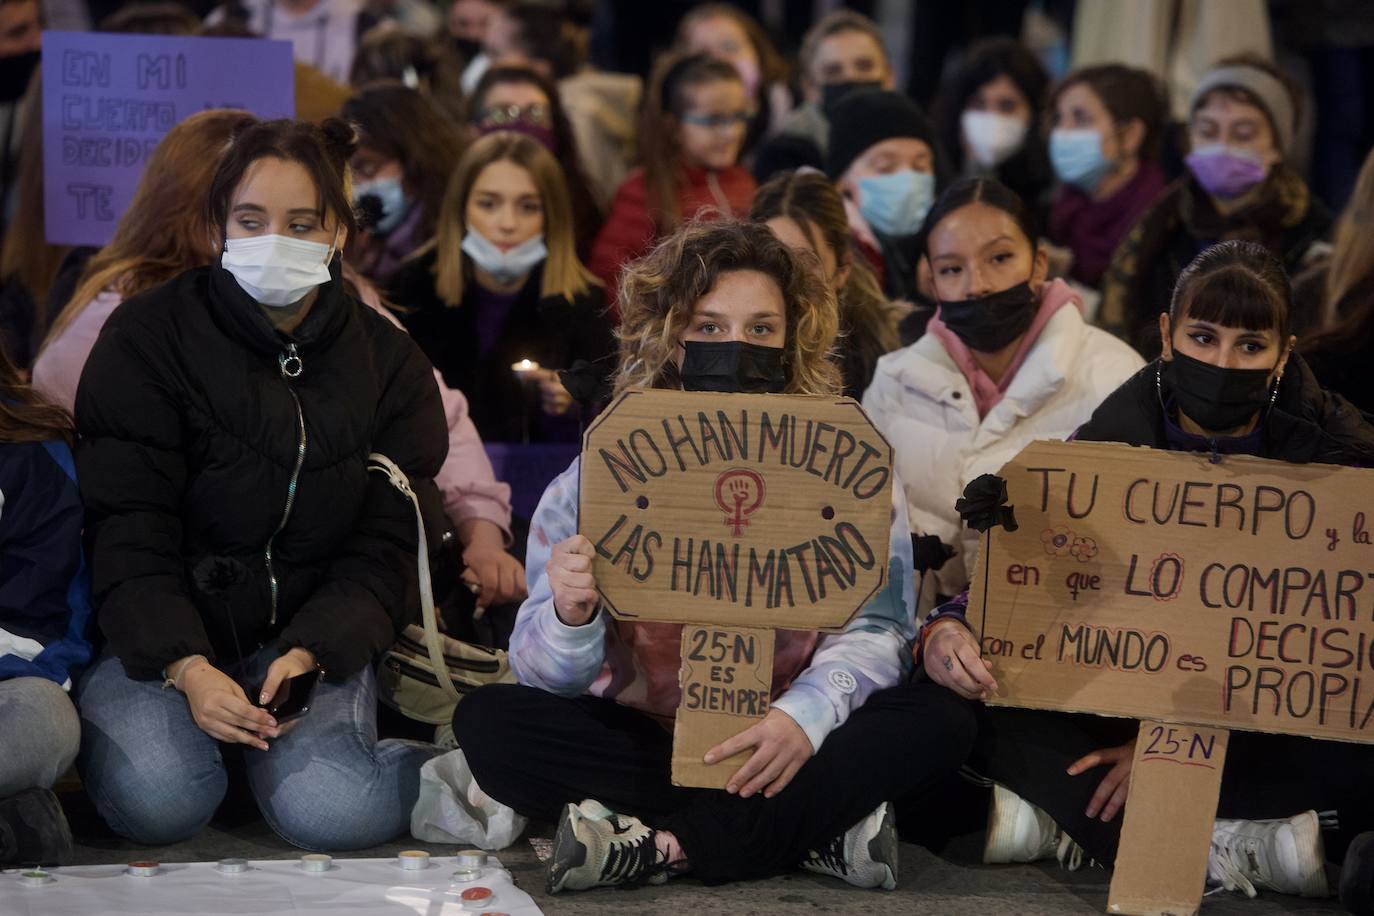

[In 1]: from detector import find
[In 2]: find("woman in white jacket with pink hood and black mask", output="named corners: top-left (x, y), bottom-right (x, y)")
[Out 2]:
top-left (863, 179), bottom-right (1140, 608)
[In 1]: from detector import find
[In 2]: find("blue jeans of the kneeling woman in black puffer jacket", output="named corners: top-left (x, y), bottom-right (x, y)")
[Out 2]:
top-left (76, 650), bottom-right (440, 850)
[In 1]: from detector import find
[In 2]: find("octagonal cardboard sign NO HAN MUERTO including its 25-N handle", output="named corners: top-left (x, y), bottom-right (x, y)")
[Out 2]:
top-left (578, 389), bottom-right (893, 788)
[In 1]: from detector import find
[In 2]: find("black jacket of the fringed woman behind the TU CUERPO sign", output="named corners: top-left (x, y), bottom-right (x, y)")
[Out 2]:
top-left (1073, 354), bottom-right (1374, 467)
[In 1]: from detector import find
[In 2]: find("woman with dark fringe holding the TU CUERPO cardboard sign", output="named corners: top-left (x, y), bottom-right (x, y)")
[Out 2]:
top-left (923, 242), bottom-right (1374, 913)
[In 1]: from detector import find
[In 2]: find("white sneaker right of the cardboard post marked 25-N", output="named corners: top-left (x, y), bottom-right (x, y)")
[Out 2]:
top-left (1206, 812), bottom-right (1330, 897)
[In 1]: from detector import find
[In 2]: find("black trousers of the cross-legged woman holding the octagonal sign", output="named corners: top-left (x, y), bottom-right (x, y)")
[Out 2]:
top-left (453, 683), bottom-right (974, 884)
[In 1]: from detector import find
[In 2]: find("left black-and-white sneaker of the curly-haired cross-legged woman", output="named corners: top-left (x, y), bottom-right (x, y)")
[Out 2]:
top-left (545, 798), bottom-right (679, 894)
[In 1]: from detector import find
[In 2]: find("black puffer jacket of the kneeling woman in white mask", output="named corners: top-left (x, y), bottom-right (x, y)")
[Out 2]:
top-left (76, 265), bottom-right (448, 678)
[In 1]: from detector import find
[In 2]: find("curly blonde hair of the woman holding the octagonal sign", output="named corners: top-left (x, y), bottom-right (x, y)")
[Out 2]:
top-left (616, 220), bottom-right (841, 394)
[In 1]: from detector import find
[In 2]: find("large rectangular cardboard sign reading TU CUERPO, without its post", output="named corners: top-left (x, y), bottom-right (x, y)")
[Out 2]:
top-left (969, 442), bottom-right (1374, 743)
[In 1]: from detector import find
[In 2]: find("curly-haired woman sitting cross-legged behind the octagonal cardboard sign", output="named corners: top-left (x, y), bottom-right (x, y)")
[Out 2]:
top-left (453, 222), bottom-right (971, 893)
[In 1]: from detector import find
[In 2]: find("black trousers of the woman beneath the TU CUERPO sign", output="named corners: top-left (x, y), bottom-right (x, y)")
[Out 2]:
top-left (969, 703), bottom-right (1374, 862)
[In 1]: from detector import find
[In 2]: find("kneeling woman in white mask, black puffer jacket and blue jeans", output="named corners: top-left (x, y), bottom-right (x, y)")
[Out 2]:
top-left (76, 121), bottom-right (447, 849)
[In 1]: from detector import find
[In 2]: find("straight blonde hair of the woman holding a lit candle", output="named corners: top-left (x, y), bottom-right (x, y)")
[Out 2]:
top-left (428, 130), bottom-right (599, 308)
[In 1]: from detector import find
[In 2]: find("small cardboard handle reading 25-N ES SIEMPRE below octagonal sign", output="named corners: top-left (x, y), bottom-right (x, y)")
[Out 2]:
top-left (673, 626), bottom-right (774, 788)
